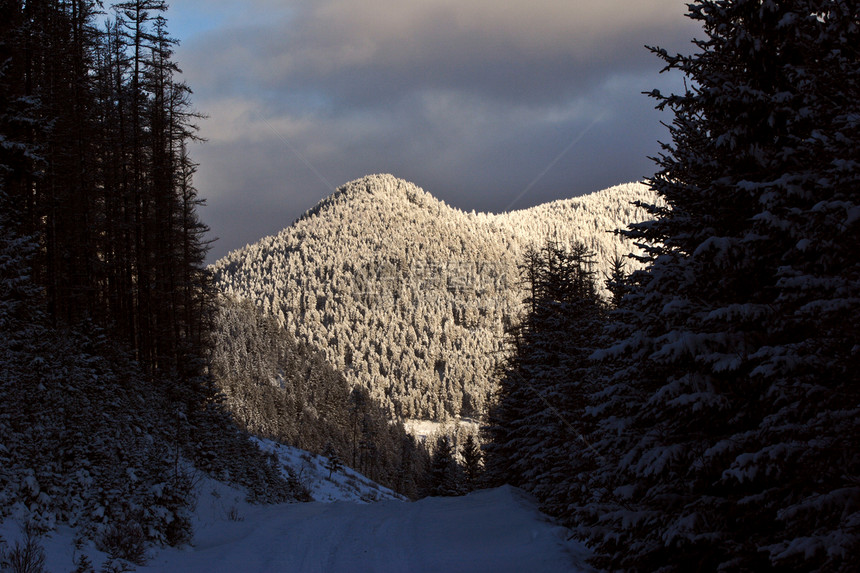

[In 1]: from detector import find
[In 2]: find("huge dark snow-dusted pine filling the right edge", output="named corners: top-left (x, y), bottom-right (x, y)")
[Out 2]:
top-left (578, 0), bottom-right (860, 571)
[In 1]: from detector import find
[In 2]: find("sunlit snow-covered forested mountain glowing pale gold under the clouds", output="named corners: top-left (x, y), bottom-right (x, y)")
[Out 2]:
top-left (213, 175), bottom-right (654, 420)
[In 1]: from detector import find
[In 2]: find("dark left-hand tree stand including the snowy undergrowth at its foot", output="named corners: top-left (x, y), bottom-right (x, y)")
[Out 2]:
top-left (0, 0), bottom-right (297, 553)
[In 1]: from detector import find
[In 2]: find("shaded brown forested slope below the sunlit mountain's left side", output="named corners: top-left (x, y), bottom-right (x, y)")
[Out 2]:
top-left (209, 298), bottom-right (429, 498)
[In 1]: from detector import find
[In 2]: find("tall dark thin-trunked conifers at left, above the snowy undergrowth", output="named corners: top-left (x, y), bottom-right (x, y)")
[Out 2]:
top-left (0, 0), bottom-right (210, 377)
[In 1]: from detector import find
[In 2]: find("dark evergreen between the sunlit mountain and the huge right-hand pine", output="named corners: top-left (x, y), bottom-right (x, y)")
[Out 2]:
top-left (485, 243), bottom-right (605, 515)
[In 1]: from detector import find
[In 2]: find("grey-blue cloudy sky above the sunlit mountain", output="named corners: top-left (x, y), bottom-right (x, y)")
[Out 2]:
top-left (167, 0), bottom-right (701, 260)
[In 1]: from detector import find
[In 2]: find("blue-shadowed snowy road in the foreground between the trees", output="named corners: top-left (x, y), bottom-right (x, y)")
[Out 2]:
top-left (138, 487), bottom-right (587, 573)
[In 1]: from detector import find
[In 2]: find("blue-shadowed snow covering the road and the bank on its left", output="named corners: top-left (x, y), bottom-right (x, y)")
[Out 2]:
top-left (0, 441), bottom-right (588, 573)
